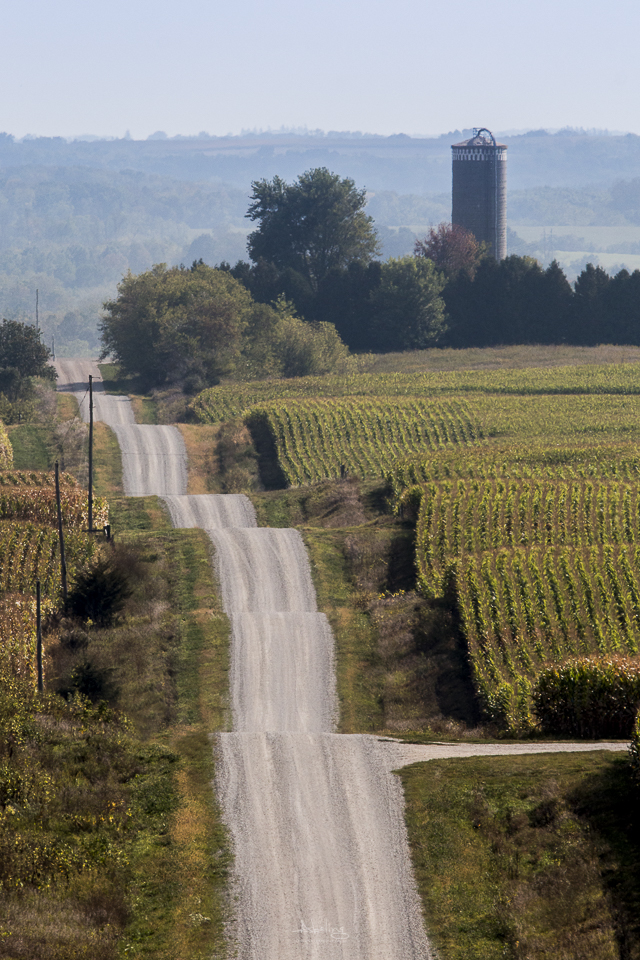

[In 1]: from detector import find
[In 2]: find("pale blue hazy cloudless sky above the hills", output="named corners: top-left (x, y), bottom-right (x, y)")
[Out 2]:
top-left (0, 0), bottom-right (640, 139)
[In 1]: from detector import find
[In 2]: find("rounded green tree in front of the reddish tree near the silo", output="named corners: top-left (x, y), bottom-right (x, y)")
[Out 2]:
top-left (370, 256), bottom-right (446, 351)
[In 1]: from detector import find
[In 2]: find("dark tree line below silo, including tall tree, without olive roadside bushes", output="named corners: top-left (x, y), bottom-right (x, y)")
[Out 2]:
top-left (221, 170), bottom-right (640, 352)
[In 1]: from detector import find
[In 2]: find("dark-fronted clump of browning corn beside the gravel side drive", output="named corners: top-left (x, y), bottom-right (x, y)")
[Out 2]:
top-left (533, 657), bottom-right (640, 738)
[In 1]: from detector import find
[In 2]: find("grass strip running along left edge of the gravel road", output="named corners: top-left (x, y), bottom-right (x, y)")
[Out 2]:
top-left (114, 506), bottom-right (230, 960)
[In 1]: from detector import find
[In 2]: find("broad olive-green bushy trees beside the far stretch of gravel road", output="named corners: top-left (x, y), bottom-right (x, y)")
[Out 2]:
top-left (102, 262), bottom-right (349, 393)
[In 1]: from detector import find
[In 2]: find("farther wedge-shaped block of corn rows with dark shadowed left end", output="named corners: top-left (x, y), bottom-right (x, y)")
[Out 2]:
top-left (247, 398), bottom-right (482, 486)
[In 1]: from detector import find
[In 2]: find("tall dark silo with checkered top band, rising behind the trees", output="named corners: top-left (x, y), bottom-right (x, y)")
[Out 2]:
top-left (451, 127), bottom-right (507, 260)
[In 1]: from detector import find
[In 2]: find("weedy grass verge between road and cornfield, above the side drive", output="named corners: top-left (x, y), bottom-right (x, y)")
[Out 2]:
top-left (252, 481), bottom-right (488, 739)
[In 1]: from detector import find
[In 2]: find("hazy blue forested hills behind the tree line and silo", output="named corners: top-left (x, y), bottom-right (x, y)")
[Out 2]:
top-left (0, 131), bottom-right (640, 355)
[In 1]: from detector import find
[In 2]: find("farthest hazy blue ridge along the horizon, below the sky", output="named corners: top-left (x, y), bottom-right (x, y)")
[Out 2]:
top-left (0, 130), bottom-right (640, 194)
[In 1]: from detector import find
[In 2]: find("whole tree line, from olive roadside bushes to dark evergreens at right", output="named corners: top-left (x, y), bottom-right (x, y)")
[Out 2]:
top-left (102, 168), bottom-right (640, 392)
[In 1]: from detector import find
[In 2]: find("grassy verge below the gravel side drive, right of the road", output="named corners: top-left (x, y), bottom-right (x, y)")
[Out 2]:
top-left (399, 753), bottom-right (640, 960)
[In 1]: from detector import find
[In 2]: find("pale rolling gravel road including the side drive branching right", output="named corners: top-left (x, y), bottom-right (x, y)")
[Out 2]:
top-left (57, 361), bottom-right (623, 960)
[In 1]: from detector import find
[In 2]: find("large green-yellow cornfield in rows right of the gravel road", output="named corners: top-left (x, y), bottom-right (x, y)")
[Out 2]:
top-left (192, 361), bottom-right (640, 731)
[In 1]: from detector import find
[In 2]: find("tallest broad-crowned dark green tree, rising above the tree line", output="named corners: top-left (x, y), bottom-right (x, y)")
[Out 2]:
top-left (247, 167), bottom-right (379, 291)
